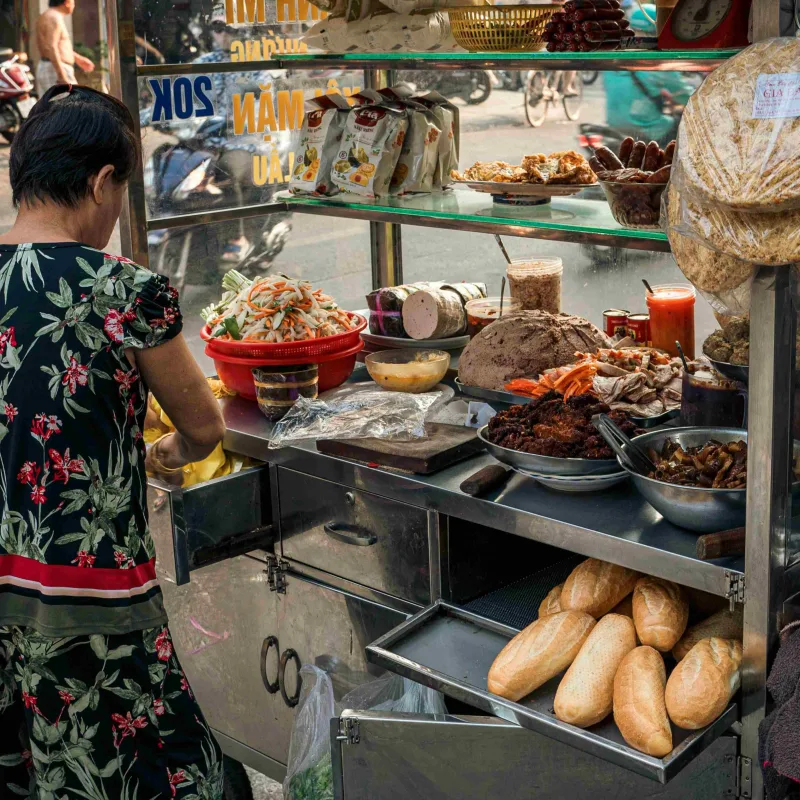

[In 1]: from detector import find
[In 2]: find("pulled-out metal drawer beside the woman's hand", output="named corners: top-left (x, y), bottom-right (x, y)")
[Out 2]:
top-left (147, 464), bottom-right (274, 586)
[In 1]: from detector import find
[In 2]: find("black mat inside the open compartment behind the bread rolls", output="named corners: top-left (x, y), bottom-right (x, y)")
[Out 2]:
top-left (464, 555), bottom-right (586, 630)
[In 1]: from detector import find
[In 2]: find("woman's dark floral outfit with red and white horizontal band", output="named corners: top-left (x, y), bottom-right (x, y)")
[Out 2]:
top-left (0, 243), bottom-right (222, 800)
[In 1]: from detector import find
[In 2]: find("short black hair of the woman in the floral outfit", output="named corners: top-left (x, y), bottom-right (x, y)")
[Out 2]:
top-left (9, 84), bottom-right (141, 208)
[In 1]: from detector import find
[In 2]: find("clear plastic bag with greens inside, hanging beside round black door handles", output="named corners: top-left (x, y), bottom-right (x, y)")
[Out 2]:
top-left (283, 664), bottom-right (336, 800)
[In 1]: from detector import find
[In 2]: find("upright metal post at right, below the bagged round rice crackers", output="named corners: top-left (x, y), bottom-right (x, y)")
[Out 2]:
top-left (742, 266), bottom-right (796, 799)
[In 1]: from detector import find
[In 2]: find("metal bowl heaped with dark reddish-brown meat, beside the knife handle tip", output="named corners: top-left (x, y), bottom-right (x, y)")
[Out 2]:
top-left (478, 392), bottom-right (641, 477)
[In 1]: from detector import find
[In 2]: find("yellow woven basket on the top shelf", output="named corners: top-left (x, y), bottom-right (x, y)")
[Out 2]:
top-left (448, 3), bottom-right (561, 53)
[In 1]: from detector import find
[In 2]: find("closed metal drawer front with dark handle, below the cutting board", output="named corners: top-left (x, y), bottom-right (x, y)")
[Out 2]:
top-left (278, 469), bottom-right (431, 605)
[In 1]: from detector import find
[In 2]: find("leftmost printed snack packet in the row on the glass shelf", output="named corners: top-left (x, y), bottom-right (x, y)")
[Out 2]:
top-left (289, 94), bottom-right (350, 195)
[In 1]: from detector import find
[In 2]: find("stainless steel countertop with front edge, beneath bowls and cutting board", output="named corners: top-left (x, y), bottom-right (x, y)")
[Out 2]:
top-left (222, 398), bottom-right (744, 597)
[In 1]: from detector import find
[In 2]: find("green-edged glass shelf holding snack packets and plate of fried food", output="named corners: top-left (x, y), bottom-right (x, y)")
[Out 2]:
top-left (278, 189), bottom-right (669, 252)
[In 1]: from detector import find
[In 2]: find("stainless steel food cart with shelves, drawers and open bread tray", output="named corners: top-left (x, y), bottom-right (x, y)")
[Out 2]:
top-left (108, 0), bottom-right (800, 800)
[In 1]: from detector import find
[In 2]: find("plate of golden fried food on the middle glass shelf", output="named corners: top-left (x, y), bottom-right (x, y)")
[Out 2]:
top-left (450, 150), bottom-right (597, 205)
